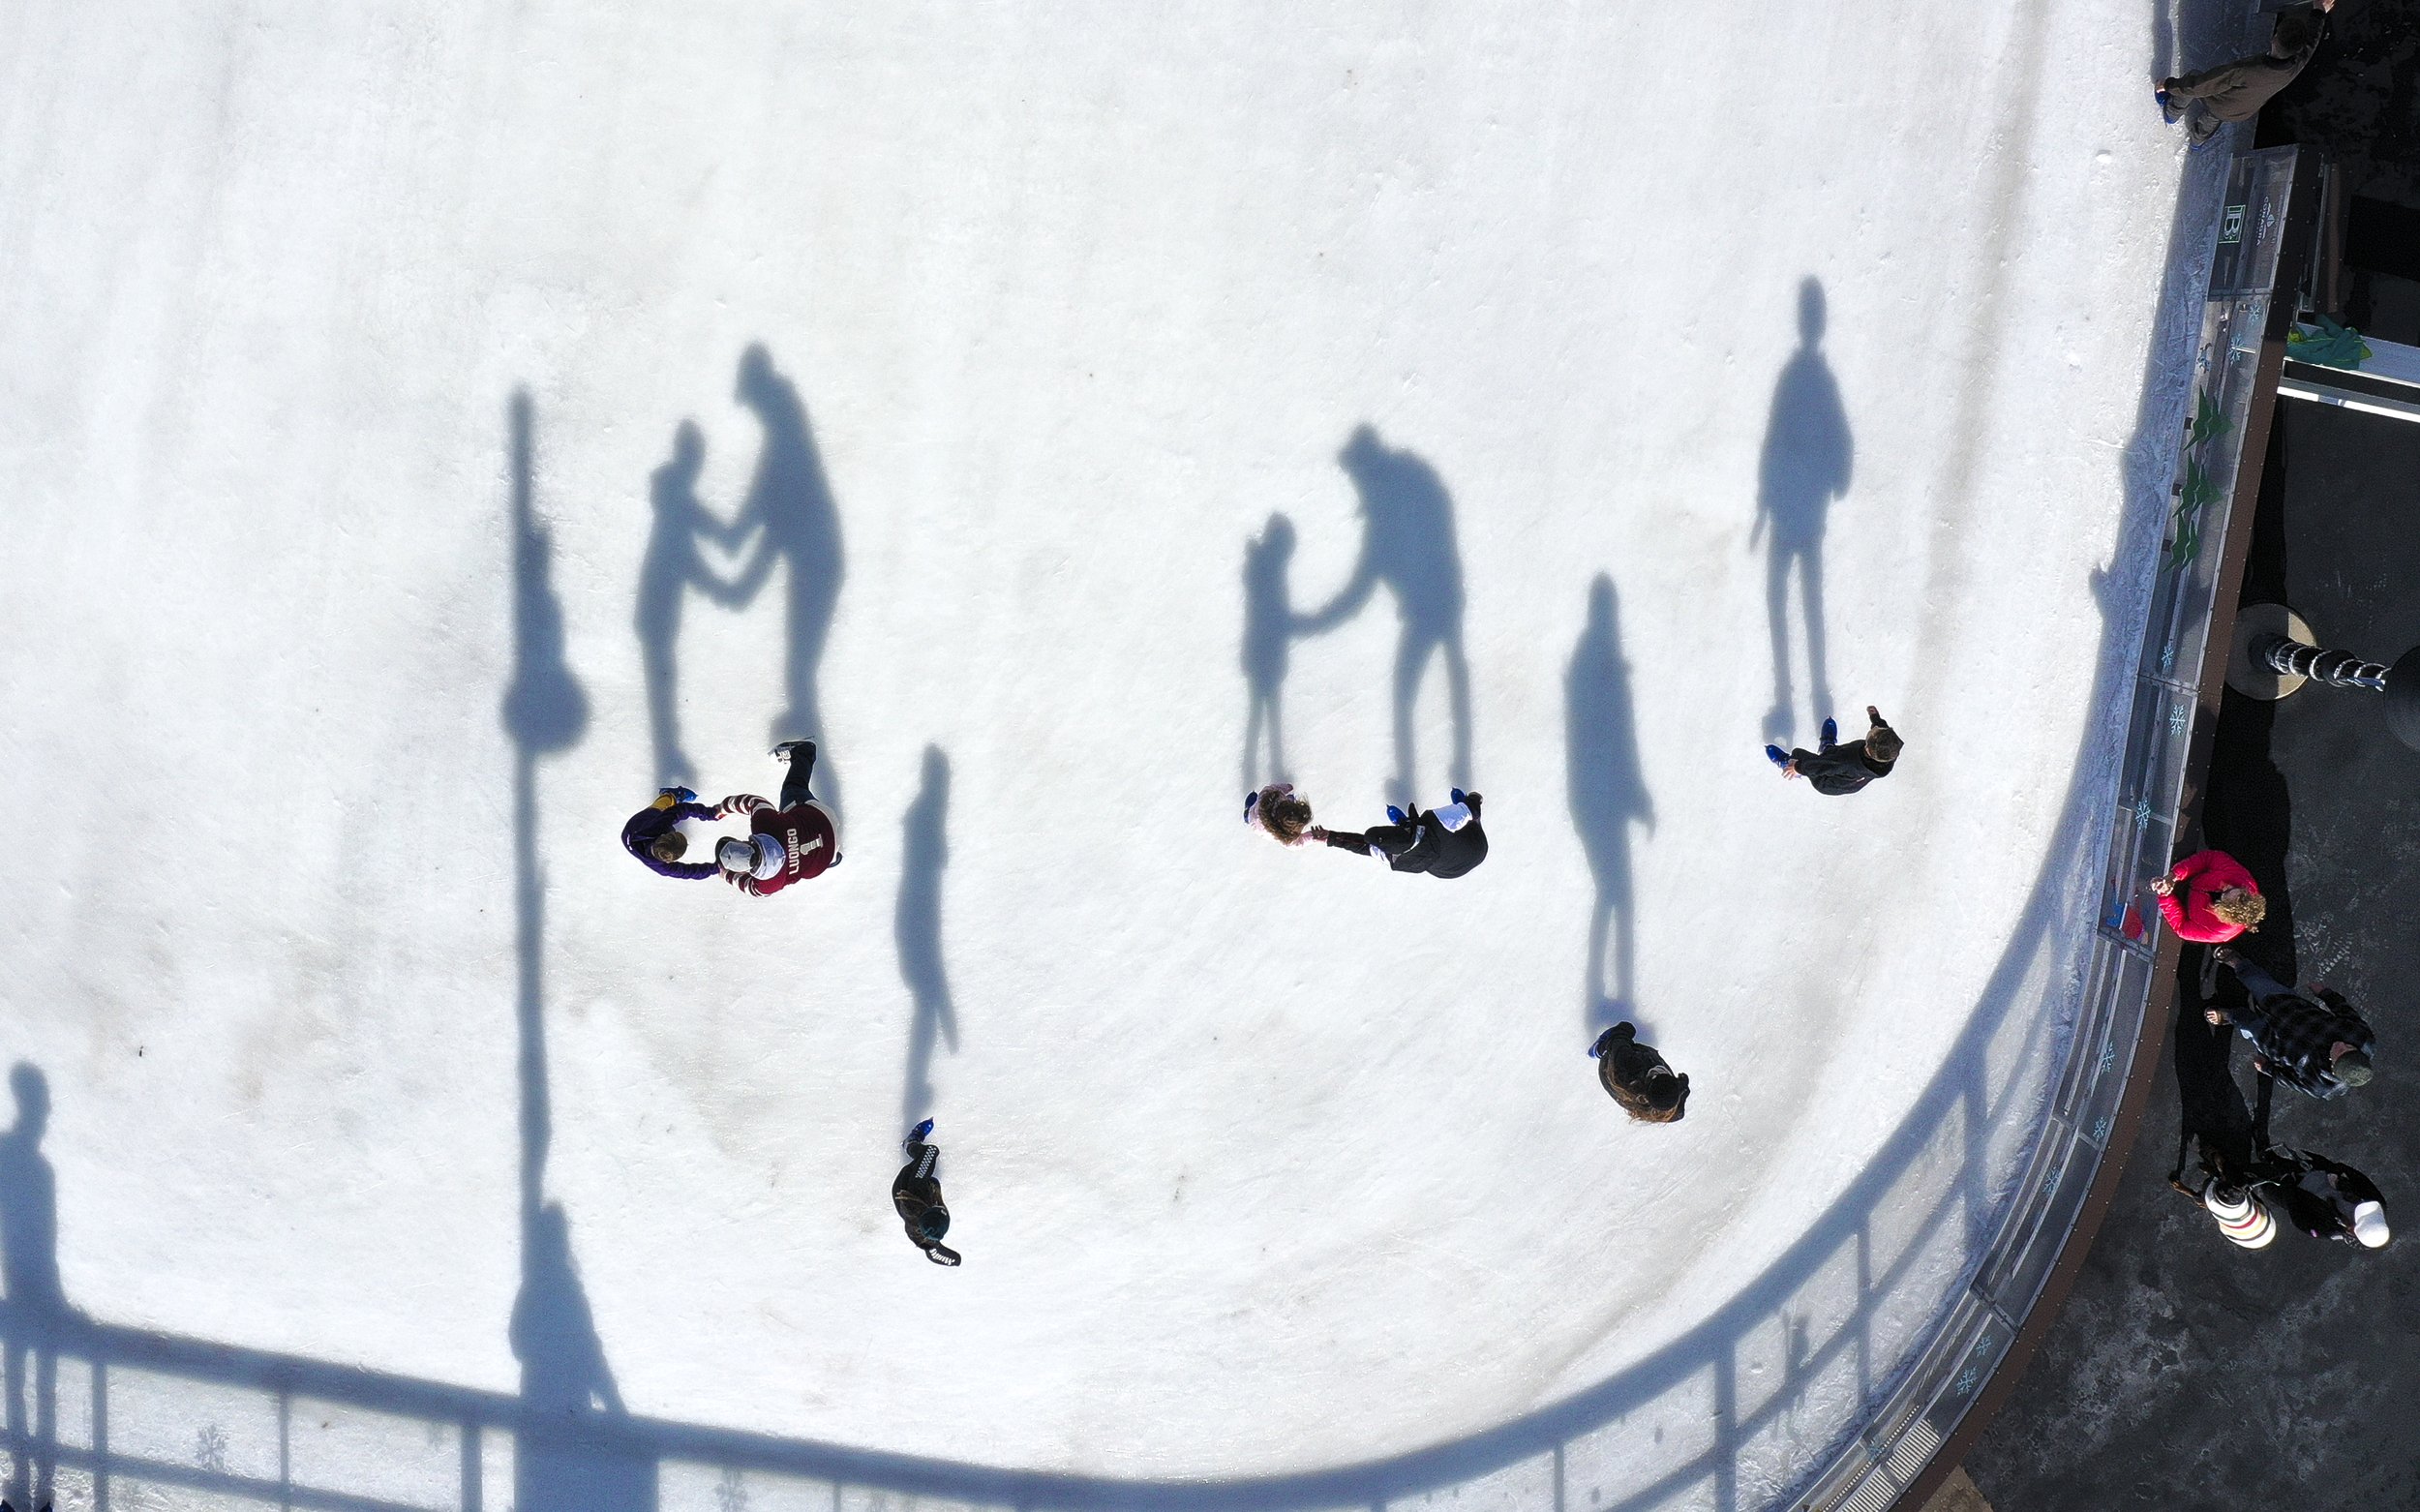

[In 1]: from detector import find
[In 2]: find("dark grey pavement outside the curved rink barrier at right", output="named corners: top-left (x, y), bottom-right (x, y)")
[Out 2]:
top-left (1965, 402), bottom-right (2420, 1512)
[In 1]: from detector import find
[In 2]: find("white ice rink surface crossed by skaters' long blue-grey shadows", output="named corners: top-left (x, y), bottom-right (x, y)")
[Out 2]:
top-left (0, 0), bottom-right (2217, 1512)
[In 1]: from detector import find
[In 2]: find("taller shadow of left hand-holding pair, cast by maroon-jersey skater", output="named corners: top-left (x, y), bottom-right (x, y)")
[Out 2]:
top-left (731, 346), bottom-right (845, 813)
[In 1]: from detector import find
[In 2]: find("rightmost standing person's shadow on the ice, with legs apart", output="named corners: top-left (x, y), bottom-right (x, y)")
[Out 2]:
top-left (1747, 278), bottom-right (1854, 741)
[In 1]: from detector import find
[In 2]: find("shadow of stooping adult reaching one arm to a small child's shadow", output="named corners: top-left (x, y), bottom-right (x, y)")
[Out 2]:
top-left (1297, 426), bottom-right (1471, 808)
